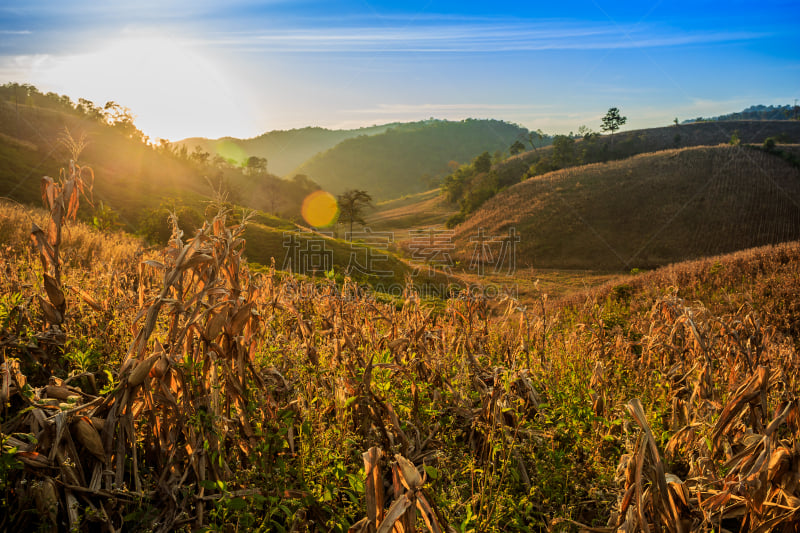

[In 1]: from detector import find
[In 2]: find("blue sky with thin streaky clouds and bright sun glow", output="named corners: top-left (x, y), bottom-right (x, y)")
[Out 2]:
top-left (0, 0), bottom-right (800, 141)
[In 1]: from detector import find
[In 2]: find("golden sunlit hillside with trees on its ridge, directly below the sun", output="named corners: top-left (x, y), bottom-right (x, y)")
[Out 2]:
top-left (0, 84), bottom-right (318, 231)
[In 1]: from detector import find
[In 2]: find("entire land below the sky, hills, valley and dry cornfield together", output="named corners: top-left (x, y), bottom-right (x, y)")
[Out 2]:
top-left (0, 86), bottom-right (800, 533)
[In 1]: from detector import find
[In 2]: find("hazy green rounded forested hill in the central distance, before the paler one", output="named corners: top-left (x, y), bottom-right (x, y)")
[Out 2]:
top-left (293, 119), bottom-right (528, 199)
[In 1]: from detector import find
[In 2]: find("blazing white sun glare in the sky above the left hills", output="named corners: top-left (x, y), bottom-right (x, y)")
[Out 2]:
top-left (40, 32), bottom-right (258, 140)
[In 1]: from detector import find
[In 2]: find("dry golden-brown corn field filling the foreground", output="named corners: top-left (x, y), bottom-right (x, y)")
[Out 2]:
top-left (0, 156), bottom-right (800, 533)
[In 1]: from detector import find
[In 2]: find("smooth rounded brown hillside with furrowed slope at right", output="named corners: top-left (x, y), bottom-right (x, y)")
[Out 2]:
top-left (455, 145), bottom-right (800, 270)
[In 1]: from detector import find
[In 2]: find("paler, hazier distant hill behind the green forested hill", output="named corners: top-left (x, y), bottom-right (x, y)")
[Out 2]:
top-left (175, 124), bottom-right (397, 178)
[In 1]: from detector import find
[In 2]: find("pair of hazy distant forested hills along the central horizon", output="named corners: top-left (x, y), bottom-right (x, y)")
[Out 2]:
top-left (178, 119), bottom-right (528, 199)
